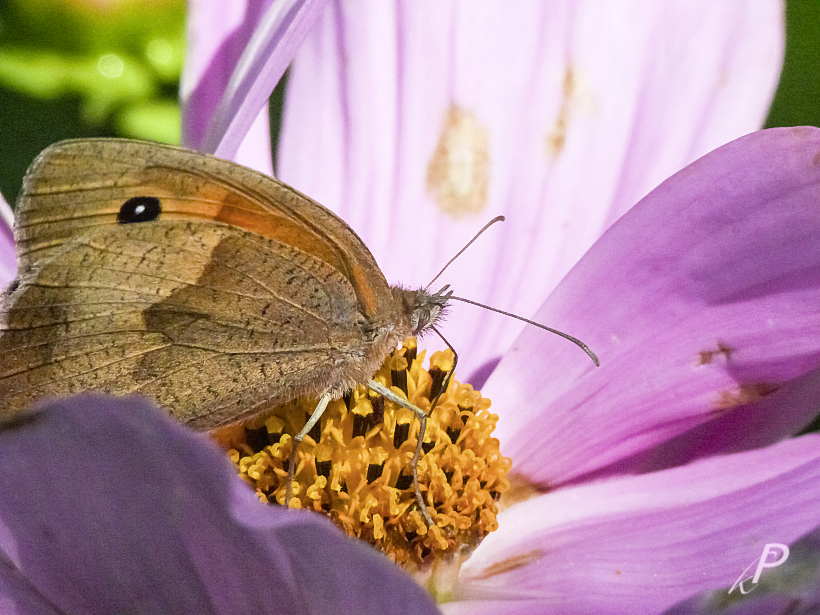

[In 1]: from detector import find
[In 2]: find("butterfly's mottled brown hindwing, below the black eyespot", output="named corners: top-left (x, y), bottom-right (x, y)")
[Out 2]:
top-left (0, 220), bottom-right (364, 428)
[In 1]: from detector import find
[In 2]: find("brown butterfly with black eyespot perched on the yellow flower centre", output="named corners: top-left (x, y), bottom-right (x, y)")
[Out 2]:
top-left (0, 139), bottom-right (450, 520)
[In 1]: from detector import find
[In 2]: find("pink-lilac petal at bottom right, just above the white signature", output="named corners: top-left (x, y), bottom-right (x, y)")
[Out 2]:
top-left (444, 435), bottom-right (820, 615)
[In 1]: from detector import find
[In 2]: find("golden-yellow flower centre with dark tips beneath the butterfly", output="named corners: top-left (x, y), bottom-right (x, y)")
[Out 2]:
top-left (221, 338), bottom-right (511, 572)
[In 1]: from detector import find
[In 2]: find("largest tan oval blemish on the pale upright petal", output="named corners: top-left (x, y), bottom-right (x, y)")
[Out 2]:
top-left (427, 105), bottom-right (490, 218)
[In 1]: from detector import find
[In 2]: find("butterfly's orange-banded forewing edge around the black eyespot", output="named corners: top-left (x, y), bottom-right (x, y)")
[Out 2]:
top-left (15, 139), bottom-right (392, 317)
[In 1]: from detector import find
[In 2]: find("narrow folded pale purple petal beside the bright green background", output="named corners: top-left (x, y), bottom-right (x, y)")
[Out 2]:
top-left (182, 0), bottom-right (327, 165)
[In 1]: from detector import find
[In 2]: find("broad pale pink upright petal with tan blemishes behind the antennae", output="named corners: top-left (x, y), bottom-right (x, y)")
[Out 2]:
top-left (278, 0), bottom-right (783, 374)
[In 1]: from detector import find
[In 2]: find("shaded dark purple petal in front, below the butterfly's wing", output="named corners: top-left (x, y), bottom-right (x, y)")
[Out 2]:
top-left (0, 395), bottom-right (437, 613)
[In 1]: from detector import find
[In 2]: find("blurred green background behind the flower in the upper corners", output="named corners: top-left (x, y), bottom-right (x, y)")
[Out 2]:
top-left (0, 0), bottom-right (820, 203)
